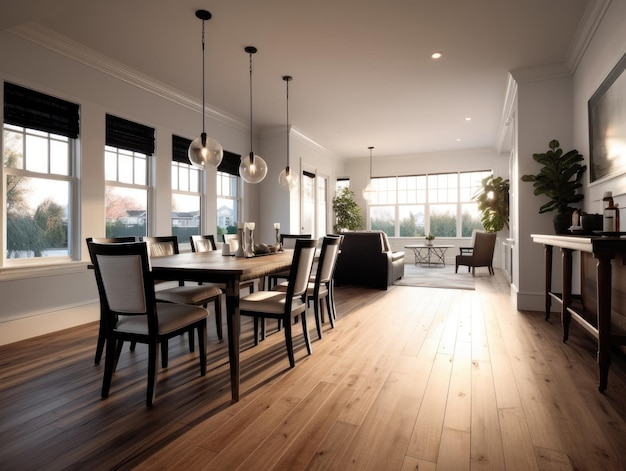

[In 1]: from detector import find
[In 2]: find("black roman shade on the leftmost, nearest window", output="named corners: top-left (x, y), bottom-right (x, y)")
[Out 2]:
top-left (4, 82), bottom-right (79, 139)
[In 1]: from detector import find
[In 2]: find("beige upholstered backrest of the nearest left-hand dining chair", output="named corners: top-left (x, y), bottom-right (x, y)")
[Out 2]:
top-left (88, 242), bottom-right (156, 322)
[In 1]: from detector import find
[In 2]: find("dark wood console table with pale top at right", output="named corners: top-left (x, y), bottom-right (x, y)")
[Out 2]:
top-left (531, 234), bottom-right (626, 391)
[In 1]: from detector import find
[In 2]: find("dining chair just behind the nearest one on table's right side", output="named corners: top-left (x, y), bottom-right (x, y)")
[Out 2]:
top-left (274, 236), bottom-right (341, 339)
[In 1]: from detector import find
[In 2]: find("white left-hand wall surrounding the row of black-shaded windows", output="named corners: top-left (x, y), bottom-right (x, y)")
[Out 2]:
top-left (0, 32), bottom-right (259, 344)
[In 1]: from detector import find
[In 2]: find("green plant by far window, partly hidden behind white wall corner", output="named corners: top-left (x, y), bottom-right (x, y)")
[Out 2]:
top-left (474, 175), bottom-right (509, 232)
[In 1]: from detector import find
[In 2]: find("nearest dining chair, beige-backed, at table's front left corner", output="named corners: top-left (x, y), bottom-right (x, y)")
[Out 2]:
top-left (88, 242), bottom-right (207, 407)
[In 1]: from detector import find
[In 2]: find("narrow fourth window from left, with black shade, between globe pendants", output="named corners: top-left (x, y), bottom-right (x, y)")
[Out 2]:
top-left (217, 151), bottom-right (241, 239)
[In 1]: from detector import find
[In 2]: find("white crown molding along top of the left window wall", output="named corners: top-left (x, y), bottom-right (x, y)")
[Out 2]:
top-left (7, 22), bottom-right (250, 133)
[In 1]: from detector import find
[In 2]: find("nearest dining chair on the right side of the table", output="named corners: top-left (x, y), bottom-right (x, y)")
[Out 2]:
top-left (239, 239), bottom-right (317, 368)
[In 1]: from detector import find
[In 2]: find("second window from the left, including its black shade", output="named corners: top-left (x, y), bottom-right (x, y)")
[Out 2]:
top-left (104, 114), bottom-right (154, 237)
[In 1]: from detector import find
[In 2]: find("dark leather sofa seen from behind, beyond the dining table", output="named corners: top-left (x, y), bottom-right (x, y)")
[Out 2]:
top-left (335, 231), bottom-right (404, 290)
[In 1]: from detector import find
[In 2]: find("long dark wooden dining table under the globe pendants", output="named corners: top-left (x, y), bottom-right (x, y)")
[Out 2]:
top-left (150, 250), bottom-right (293, 402)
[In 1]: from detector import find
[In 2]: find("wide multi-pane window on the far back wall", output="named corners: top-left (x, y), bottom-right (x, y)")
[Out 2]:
top-left (369, 171), bottom-right (492, 237)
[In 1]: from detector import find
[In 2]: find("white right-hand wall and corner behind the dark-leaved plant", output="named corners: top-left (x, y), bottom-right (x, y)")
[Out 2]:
top-left (514, 1), bottom-right (626, 310)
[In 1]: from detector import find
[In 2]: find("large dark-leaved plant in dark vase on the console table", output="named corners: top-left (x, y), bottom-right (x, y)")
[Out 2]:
top-left (522, 140), bottom-right (587, 234)
